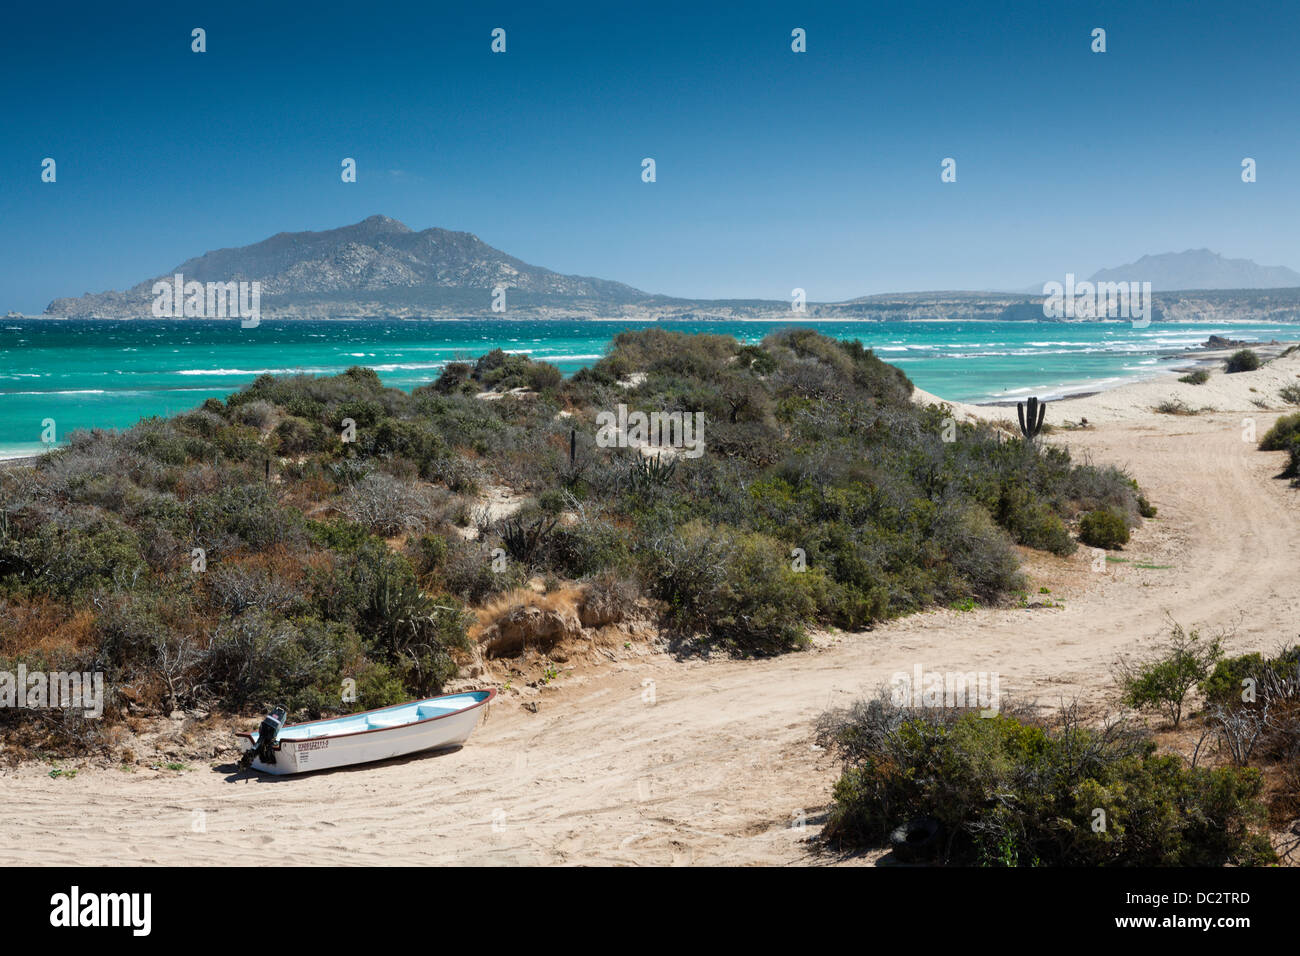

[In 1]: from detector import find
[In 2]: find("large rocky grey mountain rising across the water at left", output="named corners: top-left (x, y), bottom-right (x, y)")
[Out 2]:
top-left (46, 216), bottom-right (653, 317)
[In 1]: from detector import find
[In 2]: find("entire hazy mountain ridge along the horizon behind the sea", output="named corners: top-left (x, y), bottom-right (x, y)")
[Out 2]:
top-left (38, 216), bottom-right (1300, 321)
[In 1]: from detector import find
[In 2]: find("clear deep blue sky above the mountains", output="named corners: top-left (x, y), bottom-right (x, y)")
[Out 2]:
top-left (0, 0), bottom-right (1300, 312)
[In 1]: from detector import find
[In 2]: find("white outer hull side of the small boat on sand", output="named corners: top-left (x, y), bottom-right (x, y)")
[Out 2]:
top-left (239, 692), bottom-right (495, 775)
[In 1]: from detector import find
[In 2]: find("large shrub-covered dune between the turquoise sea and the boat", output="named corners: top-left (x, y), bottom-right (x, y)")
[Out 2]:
top-left (0, 329), bottom-right (1149, 749)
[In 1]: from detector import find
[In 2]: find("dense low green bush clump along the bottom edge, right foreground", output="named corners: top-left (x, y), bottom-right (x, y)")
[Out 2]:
top-left (818, 697), bottom-right (1274, 866)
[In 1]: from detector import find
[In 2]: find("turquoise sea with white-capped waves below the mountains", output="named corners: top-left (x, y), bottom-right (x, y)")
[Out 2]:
top-left (0, 319), bottom-right (1300, 458)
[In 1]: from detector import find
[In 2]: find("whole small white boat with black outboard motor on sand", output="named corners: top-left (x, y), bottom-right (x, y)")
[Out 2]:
top-left (235, 691), bottom-right (497, 774)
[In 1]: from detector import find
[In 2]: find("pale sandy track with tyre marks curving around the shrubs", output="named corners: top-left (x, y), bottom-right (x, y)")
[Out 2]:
top-left (0, 354), bottom-right (1300, 865)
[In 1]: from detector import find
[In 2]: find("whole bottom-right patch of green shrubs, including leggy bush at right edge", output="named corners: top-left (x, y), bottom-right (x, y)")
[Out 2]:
top-left (818, 620), bottom-right (1300, 866)
